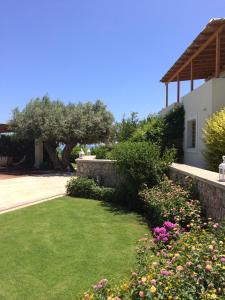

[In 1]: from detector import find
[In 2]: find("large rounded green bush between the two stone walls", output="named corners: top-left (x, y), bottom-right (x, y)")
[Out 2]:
top-left (110, 141), bottom-right (174, 206)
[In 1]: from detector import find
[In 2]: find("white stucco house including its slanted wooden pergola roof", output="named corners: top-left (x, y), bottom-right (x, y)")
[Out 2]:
top-left (161, 19), bottom-right (225, 168)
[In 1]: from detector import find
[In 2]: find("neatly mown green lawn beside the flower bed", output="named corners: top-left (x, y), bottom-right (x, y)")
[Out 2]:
top-left (0, 197), bottom-right (148, 300)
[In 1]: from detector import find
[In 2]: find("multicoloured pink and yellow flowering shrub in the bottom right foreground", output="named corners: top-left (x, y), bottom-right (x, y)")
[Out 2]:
top-left (85, 221), bottom-right (225, 300)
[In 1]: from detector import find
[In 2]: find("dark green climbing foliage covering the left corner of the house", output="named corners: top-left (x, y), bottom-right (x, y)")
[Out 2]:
top-left (164, 105), bottom-right (185, 162)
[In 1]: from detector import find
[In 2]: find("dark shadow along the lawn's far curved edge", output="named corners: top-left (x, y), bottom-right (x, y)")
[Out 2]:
top-left (101, 201), bottom-right (150, 228)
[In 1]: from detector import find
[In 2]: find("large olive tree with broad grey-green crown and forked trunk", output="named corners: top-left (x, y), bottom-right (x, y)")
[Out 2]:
top-left (10, 96), bottom-right (114, 169)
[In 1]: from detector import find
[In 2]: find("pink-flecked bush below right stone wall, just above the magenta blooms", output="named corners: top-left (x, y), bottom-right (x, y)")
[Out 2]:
top-left (139, 177), bottom-right (201, 227)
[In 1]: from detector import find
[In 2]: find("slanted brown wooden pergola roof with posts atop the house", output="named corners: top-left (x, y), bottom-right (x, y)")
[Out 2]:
top-left (160, 19), bottom-right (225, 107)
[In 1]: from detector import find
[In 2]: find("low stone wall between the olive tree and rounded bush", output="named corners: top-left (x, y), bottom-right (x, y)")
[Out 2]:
top-left (76, 158), bottom-right (119, 187)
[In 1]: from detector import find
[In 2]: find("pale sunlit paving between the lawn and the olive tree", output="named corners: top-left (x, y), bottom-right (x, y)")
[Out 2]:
top-left (0, 174), bottom-right (70, 213)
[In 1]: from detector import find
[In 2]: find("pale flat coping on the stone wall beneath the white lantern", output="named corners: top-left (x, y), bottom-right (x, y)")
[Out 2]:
top-left (170, 163), bottom-right (225, 190)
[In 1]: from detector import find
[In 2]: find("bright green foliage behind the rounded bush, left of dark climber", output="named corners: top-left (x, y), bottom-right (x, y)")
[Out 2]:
top-left (131, 115), bottom-right (165, 145)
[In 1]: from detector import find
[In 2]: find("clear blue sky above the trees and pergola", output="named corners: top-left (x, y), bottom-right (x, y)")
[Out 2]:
top-left (0, 0), bottom-right (225, 123)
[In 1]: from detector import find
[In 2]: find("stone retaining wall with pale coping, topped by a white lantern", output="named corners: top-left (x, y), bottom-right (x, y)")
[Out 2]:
top-left (170, 164), bottom-right (225, 220)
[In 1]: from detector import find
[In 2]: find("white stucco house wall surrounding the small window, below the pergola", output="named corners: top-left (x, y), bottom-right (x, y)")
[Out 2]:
top-left (181, 78), bottom-right (225, 168)
